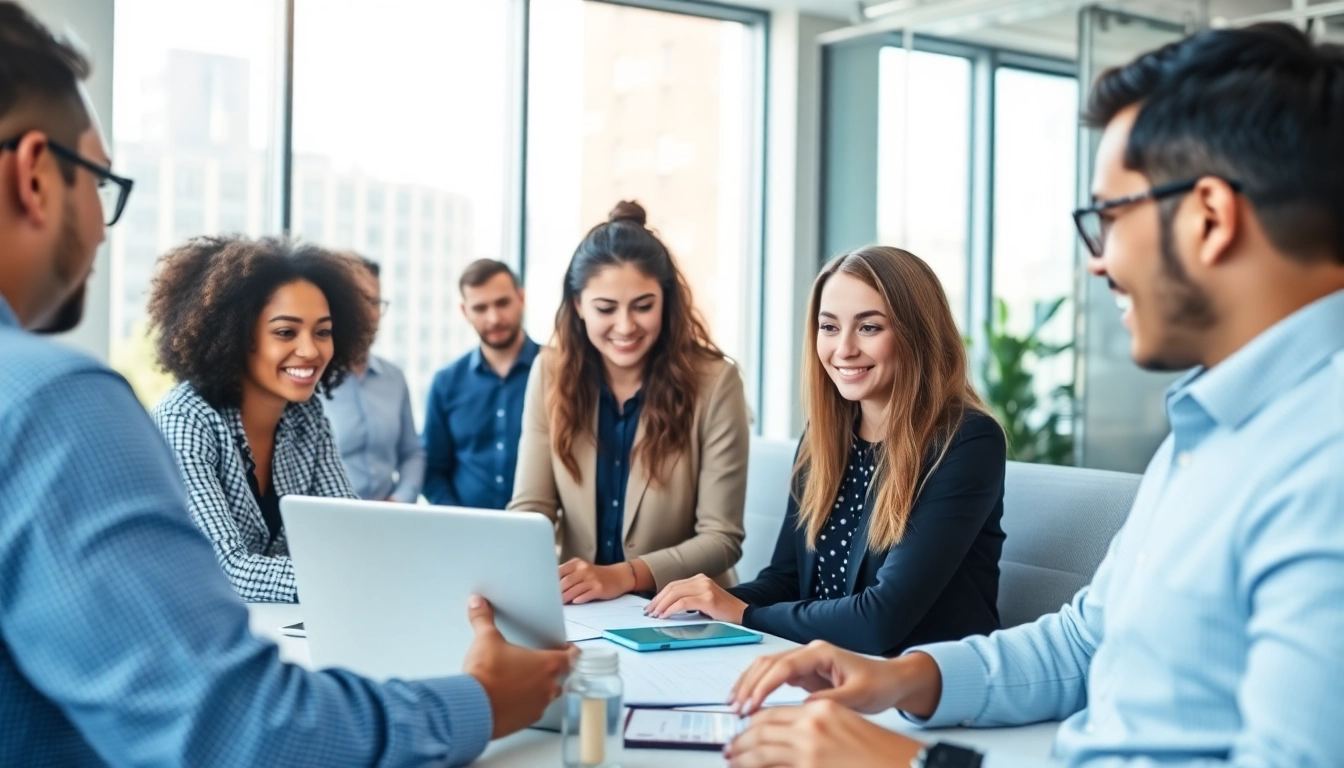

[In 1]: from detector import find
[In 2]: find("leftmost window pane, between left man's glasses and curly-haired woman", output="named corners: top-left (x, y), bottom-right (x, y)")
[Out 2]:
top-left (108, 0), bottom-right (281, 405)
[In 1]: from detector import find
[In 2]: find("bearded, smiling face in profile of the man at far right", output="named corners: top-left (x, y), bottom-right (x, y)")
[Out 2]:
top-left (1087, 106), bottom-right (1215, 370)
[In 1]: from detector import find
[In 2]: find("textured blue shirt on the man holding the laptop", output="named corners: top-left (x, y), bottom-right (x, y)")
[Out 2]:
top-left (0, 299), bottom-right (491, 767)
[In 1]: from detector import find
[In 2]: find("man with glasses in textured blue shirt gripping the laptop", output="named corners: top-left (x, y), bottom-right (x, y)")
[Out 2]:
top-left (0, 1), bottom-right (570, 765)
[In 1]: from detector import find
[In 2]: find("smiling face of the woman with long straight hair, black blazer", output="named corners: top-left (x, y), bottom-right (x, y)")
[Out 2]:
top-left (816, 272), bottom-right (896, 410)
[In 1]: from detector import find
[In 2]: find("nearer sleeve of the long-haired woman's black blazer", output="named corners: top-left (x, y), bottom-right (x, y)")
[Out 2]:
top-left (739, 414), bottom-right (1007, 655)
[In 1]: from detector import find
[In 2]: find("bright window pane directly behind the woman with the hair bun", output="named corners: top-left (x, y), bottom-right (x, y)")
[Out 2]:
top-left (527, 0), bottom-right (761, 375)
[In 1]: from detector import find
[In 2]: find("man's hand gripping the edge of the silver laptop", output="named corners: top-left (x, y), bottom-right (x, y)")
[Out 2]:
top-left (462, 594), bottom-right (578, 738)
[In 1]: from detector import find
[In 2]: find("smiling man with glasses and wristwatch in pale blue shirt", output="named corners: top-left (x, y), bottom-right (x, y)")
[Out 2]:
top-left (728, 24), bottom-right (1344, 768)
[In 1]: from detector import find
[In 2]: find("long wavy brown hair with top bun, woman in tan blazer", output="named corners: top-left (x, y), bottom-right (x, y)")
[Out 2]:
top-left (546, 200), bottom-right (723, 487)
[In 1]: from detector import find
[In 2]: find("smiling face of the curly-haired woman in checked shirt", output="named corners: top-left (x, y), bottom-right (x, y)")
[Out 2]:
top-left (243, 280), bottom-right (333, 402)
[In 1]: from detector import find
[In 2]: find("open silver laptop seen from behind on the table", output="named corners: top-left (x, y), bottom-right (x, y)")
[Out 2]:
top-left (280, 496), bottom-right (566, 726)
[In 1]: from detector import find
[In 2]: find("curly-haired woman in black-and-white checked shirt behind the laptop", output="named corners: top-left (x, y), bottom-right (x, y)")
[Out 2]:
top-left (149, 237), bottom-right (374, 601)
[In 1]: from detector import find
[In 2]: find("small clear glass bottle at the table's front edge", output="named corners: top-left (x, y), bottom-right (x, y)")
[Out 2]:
top-left (560, 648), bottom-right (625, 768)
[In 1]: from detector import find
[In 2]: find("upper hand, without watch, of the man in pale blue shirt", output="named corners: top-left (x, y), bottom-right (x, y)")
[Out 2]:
top-left (728, 640), bottom-right (942, 717)
